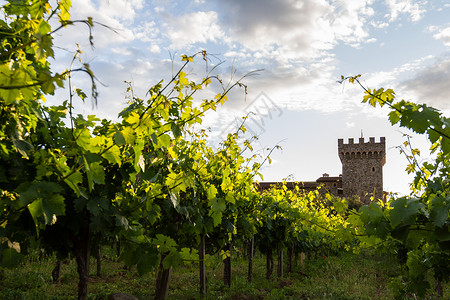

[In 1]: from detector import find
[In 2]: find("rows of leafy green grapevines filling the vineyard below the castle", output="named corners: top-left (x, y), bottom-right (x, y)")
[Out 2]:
top-left (0, 0), bottom-right (450, 299)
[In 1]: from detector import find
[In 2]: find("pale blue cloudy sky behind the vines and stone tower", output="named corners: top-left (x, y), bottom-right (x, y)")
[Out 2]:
top-left (44, 0), bottom-right (450, 194)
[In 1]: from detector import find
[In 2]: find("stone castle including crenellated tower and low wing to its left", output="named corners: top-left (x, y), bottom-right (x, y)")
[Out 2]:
top-left (259, 137), bottom-right (386, 204)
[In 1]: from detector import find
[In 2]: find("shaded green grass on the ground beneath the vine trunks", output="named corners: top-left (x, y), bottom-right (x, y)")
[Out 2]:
top-left (0, 249), bottom-right (450, 300)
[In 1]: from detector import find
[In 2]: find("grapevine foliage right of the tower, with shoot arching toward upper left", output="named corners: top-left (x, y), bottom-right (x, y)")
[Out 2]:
top-left (342, 75), bottom-right (450, 296)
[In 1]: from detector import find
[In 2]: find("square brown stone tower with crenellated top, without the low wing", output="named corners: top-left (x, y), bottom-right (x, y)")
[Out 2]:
top-left (338, 137), bottom-right (386, 203)
